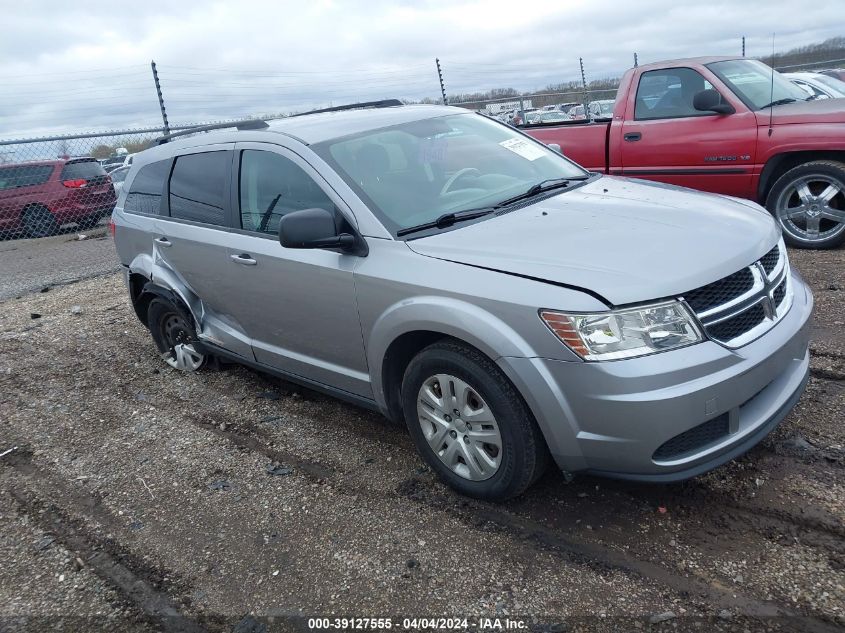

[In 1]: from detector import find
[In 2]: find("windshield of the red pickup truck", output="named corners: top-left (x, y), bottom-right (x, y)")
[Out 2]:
top-left (707, 59), bottom-right (807, 110)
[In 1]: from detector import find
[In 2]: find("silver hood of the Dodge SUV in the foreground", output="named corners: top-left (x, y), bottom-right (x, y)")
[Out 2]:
top-left (407, 176), bottom-right (780, 307)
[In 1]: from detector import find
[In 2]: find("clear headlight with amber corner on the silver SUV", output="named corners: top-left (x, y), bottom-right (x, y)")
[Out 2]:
top-left (540, 301), bottom-right (702, 360)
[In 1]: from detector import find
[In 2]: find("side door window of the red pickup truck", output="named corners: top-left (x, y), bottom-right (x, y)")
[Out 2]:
top-left (634, 68), bottom-right (713, 121)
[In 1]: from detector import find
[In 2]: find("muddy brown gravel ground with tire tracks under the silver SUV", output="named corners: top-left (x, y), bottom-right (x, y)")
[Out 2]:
top-left (0, 242), bottom-right (845, 633)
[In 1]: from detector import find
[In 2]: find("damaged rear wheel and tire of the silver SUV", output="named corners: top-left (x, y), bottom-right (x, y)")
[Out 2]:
top-left (147, 297), bottom-right (208, 372)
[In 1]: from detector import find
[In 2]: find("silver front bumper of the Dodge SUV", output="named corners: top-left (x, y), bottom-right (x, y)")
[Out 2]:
top-left (498, 271), bottom-right (813, 482)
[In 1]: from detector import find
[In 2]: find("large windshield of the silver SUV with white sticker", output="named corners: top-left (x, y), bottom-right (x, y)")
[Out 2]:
top-left (312, 114), bottom-right (587, 234)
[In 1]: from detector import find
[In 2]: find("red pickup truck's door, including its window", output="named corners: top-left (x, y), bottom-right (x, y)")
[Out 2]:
top-left (621, 68), bottom-right (757, 197)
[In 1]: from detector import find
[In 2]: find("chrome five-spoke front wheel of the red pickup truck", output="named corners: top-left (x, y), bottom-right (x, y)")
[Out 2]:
top-left (775, 174), bottom-right (845, 243)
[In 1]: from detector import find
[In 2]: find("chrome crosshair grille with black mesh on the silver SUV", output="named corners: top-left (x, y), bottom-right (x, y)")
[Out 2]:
top-left (684, 240), bottom-right (792, 347)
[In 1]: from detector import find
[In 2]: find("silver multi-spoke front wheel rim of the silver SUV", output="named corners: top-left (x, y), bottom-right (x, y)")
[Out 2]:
top-left (417, 374), bottom-right (502, 481)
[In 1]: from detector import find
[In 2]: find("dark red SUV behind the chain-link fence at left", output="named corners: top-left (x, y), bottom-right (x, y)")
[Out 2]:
top-left (0, 158), bottom-right (117, 237)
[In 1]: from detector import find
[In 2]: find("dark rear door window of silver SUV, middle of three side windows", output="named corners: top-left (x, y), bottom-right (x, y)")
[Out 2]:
top-left (170, 151), bottom-right (232, 226)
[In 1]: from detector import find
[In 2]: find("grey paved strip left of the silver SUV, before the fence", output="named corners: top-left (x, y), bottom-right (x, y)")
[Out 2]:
top-left (0, 220), bottom-right (120, 301)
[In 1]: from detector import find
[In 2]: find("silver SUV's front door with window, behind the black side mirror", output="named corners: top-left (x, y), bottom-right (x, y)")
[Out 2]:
top-left (227, 143), bottom-right (372, 398)
